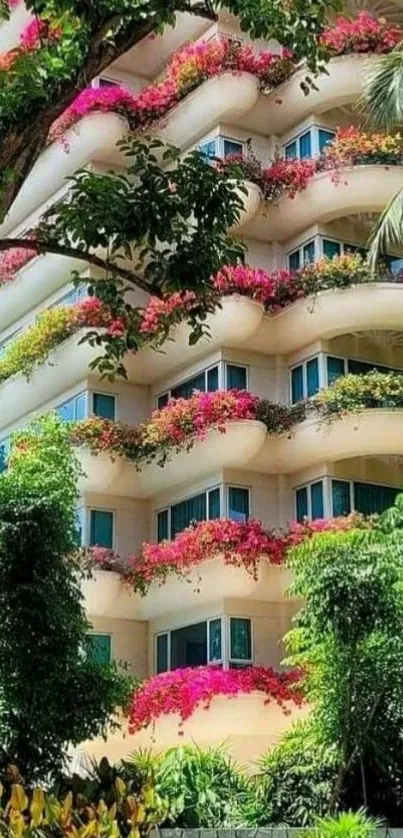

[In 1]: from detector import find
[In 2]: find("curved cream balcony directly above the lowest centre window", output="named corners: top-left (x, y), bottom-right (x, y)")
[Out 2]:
top-left (139, 556), bottom-right (291, 620)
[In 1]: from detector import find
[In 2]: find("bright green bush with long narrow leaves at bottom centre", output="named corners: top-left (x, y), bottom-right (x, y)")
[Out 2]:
top-left (152, 746), bottom-right (251, 829)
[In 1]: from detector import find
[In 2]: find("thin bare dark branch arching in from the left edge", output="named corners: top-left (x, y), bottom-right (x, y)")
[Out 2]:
top-left (0, 238), bottom-right (162, 297)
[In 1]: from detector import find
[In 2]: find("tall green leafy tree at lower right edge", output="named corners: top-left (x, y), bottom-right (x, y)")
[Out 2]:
top-left (286, 528), bottom-right (403, 821)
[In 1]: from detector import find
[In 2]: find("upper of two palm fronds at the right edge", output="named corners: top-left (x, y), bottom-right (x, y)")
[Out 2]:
top-left (359, 43), bottom-right (403, 131)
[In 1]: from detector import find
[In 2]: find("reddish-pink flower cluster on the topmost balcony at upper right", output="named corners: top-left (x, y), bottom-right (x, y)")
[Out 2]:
top-left (321, 12), bottom-right (403, 55)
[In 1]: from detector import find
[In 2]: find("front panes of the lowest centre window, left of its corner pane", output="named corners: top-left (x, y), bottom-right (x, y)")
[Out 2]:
top-left (155, 617), bottom-right (223, 673)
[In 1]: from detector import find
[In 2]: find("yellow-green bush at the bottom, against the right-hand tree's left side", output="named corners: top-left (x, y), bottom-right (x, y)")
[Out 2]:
top-left (248, 722), bottom-right (337, 826)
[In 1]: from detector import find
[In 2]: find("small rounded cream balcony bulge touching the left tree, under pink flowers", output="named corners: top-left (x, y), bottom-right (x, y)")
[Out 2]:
top-left (81, 570), bottom-right (141, 620)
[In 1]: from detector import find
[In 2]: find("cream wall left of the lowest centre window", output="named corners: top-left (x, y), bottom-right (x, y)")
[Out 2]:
top-left (91, 617), bottom-right (148, 678)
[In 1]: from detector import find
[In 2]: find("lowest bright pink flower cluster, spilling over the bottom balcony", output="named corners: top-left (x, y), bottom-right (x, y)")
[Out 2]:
top-left (129, 666), bottom-right (302, 733)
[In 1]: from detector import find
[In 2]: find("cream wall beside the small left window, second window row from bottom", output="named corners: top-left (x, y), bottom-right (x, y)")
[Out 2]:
top-left (82, 492), bottom-right (151, 556)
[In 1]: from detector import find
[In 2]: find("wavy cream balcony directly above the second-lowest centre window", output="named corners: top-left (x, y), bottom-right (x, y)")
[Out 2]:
top-left (77, 419), bottom-right (266, 498)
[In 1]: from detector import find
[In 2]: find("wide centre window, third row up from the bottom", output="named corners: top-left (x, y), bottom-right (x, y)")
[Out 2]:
top-left (157, 361), bottom-right (248, 410)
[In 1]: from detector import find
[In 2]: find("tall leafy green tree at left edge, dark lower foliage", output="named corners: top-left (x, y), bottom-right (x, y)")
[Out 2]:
top-left (0, 416), bottom-right (131, 783)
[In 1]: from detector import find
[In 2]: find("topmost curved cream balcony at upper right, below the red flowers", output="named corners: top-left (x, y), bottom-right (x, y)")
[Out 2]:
top-left (242, 55), bottom-right (378, 135)
